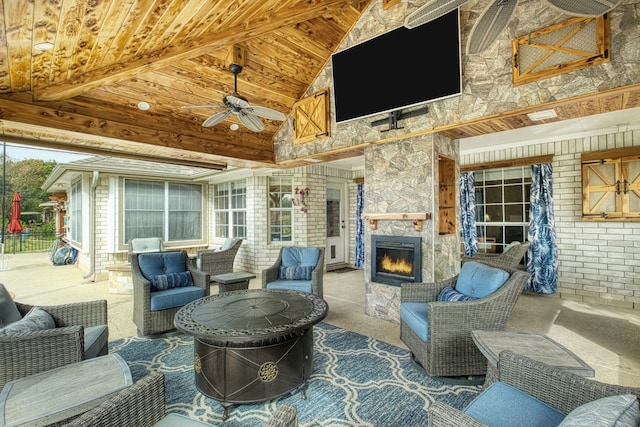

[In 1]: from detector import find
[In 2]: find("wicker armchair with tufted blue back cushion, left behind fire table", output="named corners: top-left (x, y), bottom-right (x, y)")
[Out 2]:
top-left (131, 251), bottom-right (209, 335)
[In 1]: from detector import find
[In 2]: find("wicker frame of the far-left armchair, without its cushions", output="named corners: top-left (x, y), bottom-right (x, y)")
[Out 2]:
top-left (0, 300), bottom-right (109, 389)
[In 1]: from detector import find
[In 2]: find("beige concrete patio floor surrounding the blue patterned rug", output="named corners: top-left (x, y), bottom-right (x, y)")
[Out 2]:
top-left (0, 253), bottom-right (640, 387)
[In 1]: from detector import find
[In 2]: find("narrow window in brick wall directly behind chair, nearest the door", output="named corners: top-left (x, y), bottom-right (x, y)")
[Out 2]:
top-left (269, 176), bottom-right (293, 242)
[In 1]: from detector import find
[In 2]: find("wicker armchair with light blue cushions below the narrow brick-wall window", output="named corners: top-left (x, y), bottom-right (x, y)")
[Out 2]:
top-left (262, 246), bottom-right (324, 298)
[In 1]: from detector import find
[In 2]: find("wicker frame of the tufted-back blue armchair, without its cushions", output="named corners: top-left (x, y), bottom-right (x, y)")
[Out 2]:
top-left (131, 251), bottom-right (209, 335)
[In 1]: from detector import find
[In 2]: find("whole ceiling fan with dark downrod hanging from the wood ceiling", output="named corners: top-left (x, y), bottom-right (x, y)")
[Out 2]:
top-left (183, 64), bottom-right (286, 132)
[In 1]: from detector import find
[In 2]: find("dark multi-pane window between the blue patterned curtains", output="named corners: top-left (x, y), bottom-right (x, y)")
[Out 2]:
top-left (474, 166), bottom-right (531, 253)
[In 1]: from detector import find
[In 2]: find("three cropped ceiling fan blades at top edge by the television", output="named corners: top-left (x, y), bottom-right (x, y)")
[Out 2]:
top-left (404, 0), bottom-right (622, 53)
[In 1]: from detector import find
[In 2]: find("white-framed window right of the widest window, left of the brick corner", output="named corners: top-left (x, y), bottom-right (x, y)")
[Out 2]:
top-left (213, 180), bottom-right (247, 239)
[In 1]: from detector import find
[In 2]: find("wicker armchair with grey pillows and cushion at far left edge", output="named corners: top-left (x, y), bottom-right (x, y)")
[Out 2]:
top-left (0, 284), bottom-right (109, 389)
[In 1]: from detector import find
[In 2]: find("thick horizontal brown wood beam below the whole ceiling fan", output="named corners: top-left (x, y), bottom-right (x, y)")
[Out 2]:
top-left (0, 94), bottom-right (274, 163)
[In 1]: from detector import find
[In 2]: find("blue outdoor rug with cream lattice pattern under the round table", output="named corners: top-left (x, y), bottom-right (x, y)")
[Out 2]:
top-left (109, 323), bottom-right (480, 427)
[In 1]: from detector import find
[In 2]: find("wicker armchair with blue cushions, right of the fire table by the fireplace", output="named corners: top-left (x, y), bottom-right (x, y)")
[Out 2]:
top-left (400, 262), bottom-right (530, 377)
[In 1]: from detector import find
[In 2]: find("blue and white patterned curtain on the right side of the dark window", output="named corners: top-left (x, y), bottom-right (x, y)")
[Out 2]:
top-left (526, 164), bottom-right (558, 294)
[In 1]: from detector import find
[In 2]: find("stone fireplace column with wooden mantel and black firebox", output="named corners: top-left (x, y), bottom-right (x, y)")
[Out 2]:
top-left (362, 134), bottom-right (460, 322)
